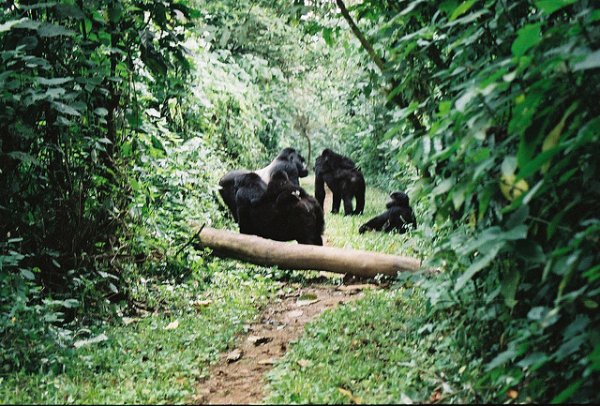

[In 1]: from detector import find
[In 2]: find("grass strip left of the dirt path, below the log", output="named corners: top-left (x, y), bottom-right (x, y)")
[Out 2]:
top-left (0, 261), bottom-right (274, 404)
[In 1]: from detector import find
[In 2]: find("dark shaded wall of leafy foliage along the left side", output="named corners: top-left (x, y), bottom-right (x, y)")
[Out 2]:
top-left (0, 0), bottom-right (197, 372)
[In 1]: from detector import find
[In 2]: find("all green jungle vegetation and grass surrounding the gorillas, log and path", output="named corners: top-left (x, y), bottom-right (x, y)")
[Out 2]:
top-left (0, 0), bottom-right (600, 403)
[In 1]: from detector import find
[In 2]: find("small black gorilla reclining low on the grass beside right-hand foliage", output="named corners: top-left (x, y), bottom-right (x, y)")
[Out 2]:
top-left (358, 192), bottom-right (417, 234)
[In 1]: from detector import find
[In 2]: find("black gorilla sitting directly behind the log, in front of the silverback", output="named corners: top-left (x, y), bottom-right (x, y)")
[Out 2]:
top-left (236, 170), bottom-right (325, 245)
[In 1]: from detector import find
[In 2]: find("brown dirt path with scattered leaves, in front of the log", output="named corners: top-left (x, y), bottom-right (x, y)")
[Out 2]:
top-left (196, 284), bottom-right (376, 404)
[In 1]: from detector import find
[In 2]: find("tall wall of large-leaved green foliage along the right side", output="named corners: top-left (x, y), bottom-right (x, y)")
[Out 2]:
top-left (307, 0), bottom-right (600, 402)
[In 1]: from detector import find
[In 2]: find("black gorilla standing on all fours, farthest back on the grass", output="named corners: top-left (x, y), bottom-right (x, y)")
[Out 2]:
top-left (315, 148), bottom-right (365, 216)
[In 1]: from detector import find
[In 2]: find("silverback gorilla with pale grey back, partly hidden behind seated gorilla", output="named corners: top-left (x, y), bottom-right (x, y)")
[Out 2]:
top-left (219, 148), bottom-right (308, 221)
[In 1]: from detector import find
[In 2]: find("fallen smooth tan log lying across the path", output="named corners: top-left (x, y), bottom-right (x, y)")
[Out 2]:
top-left (199, 227), bottom-right (421, 277)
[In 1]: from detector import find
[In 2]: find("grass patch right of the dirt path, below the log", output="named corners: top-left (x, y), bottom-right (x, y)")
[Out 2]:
top-left (266, 289), bottom-right (482, 404)
